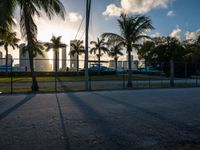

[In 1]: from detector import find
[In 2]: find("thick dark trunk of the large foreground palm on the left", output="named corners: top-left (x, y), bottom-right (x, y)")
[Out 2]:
top-left (23, 7), bottom-right (39, 92)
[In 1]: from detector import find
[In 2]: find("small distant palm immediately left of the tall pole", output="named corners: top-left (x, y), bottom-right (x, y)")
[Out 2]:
top-left (69, 40), bottom-right (85, 75)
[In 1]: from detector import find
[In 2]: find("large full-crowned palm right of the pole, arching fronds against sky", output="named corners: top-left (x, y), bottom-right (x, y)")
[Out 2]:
top-left (102, 14), bottom-right (154, 87)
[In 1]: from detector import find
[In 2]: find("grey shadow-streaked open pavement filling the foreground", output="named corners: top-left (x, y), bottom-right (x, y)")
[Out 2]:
top-left (0, 88), bottom-right (200, 150)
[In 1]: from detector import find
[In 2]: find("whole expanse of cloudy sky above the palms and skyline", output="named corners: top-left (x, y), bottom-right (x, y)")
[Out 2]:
top-left (1, 0), bottom-right (200, 58)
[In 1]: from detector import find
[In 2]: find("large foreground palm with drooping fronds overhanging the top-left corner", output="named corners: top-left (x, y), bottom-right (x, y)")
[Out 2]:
top-left (0, 0), bottom-right (65, 91)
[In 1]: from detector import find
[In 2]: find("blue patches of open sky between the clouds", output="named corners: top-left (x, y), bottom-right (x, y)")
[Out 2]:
top-left (65, 0), bottom-right (200, 40)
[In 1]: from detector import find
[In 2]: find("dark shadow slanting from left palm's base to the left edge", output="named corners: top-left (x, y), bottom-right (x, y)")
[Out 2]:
top-left (0, 94), bottom-right (35, 121)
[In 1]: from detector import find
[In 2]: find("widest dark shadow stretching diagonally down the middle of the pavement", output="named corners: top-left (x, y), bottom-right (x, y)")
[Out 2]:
top-left (66, 93), bottom-right (135, 150)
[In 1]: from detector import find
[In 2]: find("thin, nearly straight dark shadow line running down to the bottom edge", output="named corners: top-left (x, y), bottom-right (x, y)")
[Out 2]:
top-left (56, 94), bottom-right (71, 150)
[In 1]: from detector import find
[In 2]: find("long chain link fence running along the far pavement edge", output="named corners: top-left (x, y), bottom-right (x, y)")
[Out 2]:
top-left (0, 58), bottom-right (200, 93)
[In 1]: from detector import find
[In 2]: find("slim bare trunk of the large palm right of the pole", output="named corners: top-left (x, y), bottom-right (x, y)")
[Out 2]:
top-left (127, 44), bottom-right (133, 87)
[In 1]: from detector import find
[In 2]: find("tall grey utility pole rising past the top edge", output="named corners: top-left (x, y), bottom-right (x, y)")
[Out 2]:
top-left (85, 0), bottom-right (91, 90)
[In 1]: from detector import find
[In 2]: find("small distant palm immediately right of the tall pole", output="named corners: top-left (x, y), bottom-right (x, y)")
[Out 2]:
top-left (90, 38), bottom-right (109, 72)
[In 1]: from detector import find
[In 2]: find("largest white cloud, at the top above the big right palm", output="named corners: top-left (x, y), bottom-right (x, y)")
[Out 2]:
top-left (103, 0), bottom-right (174, 16)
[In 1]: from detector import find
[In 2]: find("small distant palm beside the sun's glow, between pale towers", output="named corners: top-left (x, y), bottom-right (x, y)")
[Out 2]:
top-left (45, 35), bottom-right (66, 73)
